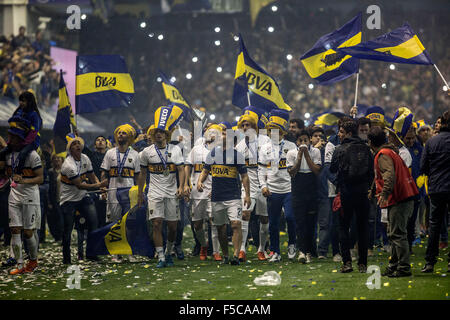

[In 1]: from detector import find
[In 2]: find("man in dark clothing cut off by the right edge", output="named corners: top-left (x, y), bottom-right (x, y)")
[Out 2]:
top-left (420, 110), bottom-right (450, 273)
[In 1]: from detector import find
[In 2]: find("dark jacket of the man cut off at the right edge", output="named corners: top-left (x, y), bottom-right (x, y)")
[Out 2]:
top-left (420, 128), bottom-right (450, 194)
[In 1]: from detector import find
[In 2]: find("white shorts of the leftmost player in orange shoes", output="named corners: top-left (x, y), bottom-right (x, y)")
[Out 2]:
top-left (8, 203), bottom-right (41, 230)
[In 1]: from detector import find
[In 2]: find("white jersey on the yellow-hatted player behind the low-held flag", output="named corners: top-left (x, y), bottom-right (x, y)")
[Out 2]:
top-left (100, 147), bottom-right (141, 203)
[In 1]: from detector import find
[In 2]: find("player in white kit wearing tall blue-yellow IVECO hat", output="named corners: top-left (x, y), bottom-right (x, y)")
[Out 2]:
top-left (138, 106), bottom-right (185, 268)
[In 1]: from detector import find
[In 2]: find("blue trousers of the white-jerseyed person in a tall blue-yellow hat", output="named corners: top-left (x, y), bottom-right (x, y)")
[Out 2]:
top-left (267, 192), bottom-right (295, 254)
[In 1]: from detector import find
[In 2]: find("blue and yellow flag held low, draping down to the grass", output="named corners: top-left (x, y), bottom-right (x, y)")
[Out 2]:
top-left (86, 186), bottom-right (155, 257)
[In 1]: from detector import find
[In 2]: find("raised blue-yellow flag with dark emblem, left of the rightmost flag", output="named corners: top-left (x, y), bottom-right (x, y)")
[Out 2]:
top-left (300, 13), bottom-right (362, 85)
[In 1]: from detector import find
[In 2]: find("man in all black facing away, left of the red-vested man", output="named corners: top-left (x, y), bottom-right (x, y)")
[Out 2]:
top-left (330, 119), bottom-right (374, 273)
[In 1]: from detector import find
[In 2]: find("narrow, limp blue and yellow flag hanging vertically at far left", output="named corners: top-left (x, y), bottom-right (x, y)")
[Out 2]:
top-left (53, 70), bottom-right (77, 156)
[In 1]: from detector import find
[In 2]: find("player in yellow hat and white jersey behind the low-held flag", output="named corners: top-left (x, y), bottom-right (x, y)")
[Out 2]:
top-left (100, 124), bottom-right (141, 262)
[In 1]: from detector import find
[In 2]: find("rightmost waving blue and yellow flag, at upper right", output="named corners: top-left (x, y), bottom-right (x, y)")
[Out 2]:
top-left (338, 23), bottom-right (433, 64)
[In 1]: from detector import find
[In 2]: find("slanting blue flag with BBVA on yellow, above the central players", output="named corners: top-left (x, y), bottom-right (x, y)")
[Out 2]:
top-left (232, 34), bottom-right (292, 111)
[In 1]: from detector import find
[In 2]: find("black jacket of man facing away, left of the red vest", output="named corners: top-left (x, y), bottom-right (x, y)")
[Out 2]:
top-left (330, 136), bottom-right (374, 194)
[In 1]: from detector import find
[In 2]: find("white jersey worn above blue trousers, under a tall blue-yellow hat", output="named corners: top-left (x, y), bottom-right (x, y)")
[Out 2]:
top-left (258, 139), bottom-right (297, 193)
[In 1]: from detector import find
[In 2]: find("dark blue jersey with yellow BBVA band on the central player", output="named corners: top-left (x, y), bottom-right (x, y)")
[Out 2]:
top-left (203, 148), bottom-right (247, 202)
